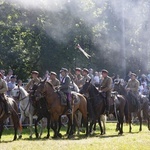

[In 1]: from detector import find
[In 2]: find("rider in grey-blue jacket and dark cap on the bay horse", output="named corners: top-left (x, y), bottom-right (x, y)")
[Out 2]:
top-left (60, 68), bottom-right (72, 113)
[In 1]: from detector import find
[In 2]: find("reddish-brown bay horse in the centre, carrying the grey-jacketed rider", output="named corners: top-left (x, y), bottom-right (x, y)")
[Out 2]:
top-left (35, 80), bottom-right (88, 138)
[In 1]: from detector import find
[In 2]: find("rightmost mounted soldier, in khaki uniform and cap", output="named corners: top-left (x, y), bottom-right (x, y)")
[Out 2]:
top-left (126, 73), bottom-right (140, 106)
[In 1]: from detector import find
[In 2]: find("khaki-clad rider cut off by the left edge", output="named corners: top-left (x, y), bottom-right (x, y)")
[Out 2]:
top-left (0, 73), bottom-right (10, 115)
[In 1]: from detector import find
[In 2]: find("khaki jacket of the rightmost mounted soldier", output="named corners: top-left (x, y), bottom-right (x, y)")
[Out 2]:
top-left (126, 79), bottom-right (139, 94)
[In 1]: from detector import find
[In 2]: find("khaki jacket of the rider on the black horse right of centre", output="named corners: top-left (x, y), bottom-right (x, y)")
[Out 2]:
top-left (100, 76), bottom-right (112, 93)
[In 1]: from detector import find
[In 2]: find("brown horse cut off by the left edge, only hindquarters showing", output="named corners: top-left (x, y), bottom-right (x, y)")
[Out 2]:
top-left (0, 96), bottom-right (20, 140)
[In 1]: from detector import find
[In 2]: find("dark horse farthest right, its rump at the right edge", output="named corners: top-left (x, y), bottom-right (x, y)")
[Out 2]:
top-left (114, 82), bottom-right (150, 132)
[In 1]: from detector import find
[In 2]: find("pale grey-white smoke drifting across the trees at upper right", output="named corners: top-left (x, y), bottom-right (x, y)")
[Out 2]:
top-left (7, 0), bottom-right (150, 73)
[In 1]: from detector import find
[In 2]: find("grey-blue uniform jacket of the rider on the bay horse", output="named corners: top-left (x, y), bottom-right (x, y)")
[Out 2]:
top-left (60, 75), bottom-right (71, 93)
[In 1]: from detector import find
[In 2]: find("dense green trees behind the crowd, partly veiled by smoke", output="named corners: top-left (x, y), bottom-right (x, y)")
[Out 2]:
top-left (0, 0), bottom-right (150, 80)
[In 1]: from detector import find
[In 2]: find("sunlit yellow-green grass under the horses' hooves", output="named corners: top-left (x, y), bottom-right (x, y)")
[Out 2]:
top-left (0, 123), bottom-right (150, 150)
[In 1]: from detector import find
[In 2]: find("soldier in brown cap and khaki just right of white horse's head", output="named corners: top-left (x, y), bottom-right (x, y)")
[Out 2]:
top-left (25, 71), bottom-right (40, 92)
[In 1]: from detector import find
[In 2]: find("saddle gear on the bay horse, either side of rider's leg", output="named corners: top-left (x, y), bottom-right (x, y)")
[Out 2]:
top-left (57, 91), bottom-right (80, 106)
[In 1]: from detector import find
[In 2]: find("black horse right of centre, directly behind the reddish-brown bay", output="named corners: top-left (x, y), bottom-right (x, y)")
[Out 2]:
top-left (80, 81), bottom-right (126, 134)
